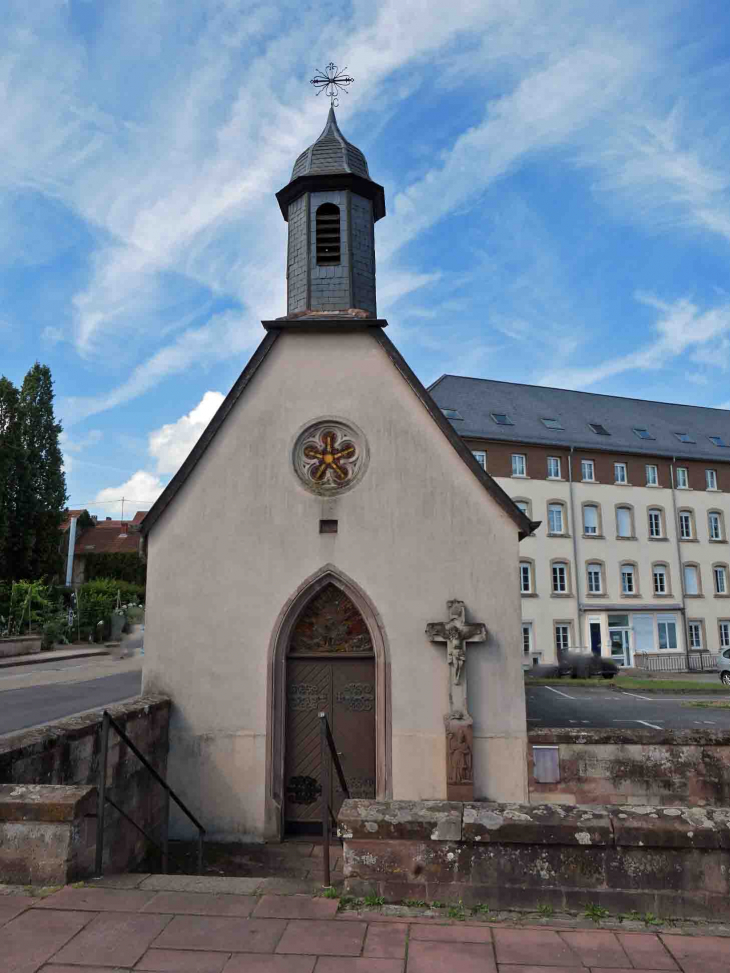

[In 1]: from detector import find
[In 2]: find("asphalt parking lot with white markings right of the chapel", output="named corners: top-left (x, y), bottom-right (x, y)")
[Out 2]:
top-left (525, 679), bottom-right (730, 732)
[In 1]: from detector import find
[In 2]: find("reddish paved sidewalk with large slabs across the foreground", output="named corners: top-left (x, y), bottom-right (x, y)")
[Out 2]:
top-left (0, 876), bottom-right (730, 973)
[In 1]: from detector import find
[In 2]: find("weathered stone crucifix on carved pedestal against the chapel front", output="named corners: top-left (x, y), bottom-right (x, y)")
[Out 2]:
top-left (426, 598), bottom-right (487, 801)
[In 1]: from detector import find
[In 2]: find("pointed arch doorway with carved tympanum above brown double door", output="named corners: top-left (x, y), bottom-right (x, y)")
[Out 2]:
top-left (283, 581), bottom-right (376, 834)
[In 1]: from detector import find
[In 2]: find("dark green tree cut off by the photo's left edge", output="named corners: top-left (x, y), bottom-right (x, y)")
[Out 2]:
top-left (0, 376), bottom-right (24, 578)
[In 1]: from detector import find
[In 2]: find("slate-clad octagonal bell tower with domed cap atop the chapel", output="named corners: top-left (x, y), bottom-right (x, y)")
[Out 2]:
top-left (276, 108), bottom-right (385, 318)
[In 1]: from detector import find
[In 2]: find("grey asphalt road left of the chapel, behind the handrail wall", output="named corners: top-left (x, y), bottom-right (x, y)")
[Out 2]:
top-left (0, 670), bottom-right (142, 733)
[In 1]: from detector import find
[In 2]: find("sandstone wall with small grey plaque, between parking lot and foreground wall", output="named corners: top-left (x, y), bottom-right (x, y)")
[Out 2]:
top-left (527, 729), bottom-right (730, 807)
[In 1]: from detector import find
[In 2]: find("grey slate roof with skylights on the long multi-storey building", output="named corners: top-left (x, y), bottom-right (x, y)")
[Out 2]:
top-left (429, 375), bottom-right (730, 462)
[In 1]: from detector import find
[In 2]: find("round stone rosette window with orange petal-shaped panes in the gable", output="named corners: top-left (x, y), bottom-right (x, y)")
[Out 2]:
top-left (292, 418), bottom-right (368, 496)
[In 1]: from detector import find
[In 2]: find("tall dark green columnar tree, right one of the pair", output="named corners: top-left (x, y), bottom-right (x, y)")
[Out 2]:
top-left (15, 362), bottom-right (68, 578)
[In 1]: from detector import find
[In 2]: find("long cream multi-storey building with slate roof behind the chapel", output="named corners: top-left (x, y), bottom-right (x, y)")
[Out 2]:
top-left (430, 375), bottom-right (730, 665)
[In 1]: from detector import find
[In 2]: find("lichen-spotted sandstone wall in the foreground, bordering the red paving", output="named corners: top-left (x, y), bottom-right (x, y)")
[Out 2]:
top-left (338, 800), bottom-right (730, 920)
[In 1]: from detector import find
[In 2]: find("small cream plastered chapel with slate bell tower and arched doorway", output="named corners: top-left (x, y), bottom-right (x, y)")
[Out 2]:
top-left (142, 102), bottom-right (535, 840)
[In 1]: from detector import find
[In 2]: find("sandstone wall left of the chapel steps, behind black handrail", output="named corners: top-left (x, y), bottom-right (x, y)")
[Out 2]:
top-left (0, 696), bottom-right (170, 884)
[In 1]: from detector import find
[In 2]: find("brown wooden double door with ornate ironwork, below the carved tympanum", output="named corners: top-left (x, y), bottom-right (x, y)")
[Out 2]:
top-left (284, 652), bottom-right (376, 834)
